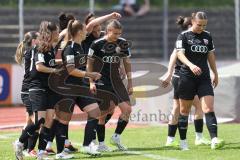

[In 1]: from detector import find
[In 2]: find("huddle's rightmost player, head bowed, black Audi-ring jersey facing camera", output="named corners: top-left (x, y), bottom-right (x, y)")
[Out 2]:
top-left (87, 20), bottom-right (133, 150)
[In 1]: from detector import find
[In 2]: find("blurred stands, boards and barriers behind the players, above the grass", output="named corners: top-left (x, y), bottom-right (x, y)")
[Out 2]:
top-left (0, 0), bottom-right (240, 128)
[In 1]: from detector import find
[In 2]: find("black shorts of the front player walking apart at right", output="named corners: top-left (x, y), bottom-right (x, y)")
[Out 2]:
top-left (178, 75), bottom-right (214, 100)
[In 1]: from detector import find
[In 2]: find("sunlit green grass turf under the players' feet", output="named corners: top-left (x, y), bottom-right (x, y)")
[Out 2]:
top-left (0, 124), bottom-right (240, 160)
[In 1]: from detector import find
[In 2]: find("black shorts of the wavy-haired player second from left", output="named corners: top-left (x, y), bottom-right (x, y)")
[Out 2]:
top-left (29, 88), bottom-right (62, 112)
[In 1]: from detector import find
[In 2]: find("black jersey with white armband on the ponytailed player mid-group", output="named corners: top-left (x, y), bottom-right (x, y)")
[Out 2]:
top-left (62, 41), bottom-right (87, 84)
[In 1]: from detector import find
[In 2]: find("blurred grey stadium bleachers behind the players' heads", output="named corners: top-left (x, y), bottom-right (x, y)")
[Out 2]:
top-left (0, 0), bottom-right (239, 63)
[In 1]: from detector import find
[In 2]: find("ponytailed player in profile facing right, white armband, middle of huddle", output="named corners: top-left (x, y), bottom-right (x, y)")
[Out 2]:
top-left (60, 20), bottom-right (101, 155)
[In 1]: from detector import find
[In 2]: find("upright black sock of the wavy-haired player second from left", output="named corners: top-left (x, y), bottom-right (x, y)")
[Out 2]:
top-left (38, 126), bottom-right (50, 150)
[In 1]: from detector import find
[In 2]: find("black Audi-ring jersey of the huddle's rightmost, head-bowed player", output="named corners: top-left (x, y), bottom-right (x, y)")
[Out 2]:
top-left (88, 37), bottom-right (131, 84)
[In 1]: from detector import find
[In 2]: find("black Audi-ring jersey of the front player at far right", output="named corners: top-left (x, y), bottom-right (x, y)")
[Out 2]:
top-left (175, 29), bottom-right (215, 78)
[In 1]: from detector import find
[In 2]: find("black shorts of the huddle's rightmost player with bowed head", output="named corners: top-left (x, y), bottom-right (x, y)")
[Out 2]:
top-left (96, 83), bottom-right (130, 110)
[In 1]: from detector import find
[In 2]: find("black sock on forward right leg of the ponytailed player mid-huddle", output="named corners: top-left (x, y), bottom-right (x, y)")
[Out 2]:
top-left (83, 118), bottom-right (98, 146)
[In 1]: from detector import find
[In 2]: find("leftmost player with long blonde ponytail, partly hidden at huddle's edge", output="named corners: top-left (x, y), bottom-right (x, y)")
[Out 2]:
top-left (15, 31), bottom-right (39, 157)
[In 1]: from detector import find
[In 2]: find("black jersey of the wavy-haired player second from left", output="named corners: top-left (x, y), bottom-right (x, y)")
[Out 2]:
top-left (30, 48), bottom-right (55, 89)
